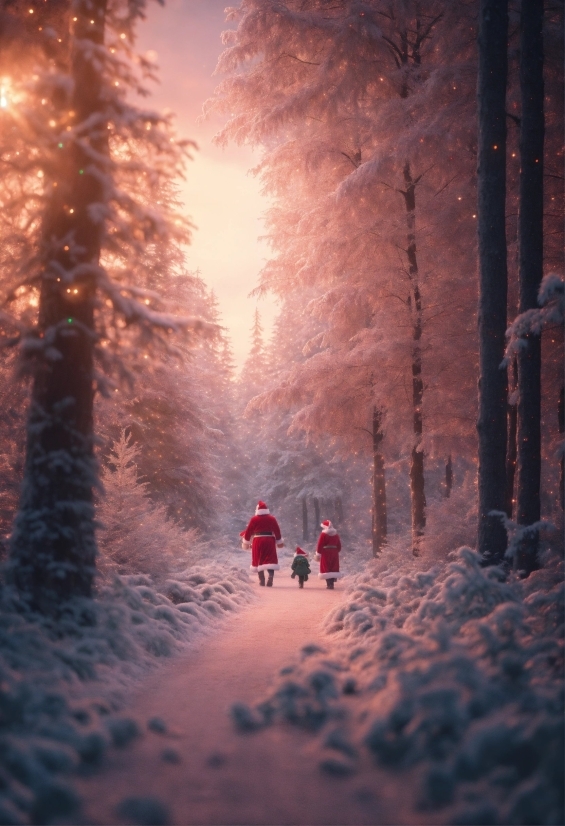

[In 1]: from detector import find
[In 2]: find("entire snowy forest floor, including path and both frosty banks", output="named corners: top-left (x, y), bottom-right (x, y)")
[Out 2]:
top-left (0, 548), bottom-right (563, 825)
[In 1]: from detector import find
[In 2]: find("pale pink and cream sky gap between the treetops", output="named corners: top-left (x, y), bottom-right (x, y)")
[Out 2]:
top-left (138, 0), bottom-right (276, 367)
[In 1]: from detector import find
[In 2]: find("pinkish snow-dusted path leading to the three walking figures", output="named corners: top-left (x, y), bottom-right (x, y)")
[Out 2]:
top-left (79, 572), bottom-right (400, 826)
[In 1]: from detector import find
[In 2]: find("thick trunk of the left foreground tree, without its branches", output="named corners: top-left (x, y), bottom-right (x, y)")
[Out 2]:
top-left (10, 0), bottom-right (108, 611)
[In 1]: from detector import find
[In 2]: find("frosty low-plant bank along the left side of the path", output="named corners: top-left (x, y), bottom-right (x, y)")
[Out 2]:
top-left (0, 566), bottom-right (253, 824)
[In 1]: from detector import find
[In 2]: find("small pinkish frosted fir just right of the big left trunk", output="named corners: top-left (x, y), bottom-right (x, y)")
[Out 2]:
top-left (98, 430), bottom-right (212, 582)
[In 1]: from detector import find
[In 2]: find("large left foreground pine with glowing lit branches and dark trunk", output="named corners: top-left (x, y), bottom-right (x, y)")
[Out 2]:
top-left (1, 0), bottom-right (195, 610)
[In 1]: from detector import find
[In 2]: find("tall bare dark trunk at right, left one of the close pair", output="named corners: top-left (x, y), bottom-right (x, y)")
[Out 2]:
top-left (477, 0), bottom-right (508, 563)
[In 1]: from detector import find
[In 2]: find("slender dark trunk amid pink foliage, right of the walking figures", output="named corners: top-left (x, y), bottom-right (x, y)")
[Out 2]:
top-left (402, 162), bottom-right (426, 556)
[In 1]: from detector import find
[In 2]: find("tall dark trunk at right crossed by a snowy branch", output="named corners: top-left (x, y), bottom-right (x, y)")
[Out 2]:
top-left (516, 0), bottom-right (545, 573)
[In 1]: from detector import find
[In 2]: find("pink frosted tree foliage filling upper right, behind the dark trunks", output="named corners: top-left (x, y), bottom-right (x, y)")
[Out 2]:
top-left (213, 0), bottom-right (563, 549)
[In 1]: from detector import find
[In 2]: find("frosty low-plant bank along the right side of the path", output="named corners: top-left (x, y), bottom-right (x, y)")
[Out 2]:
top-left (233, 548), bottom-right (563, 824)
